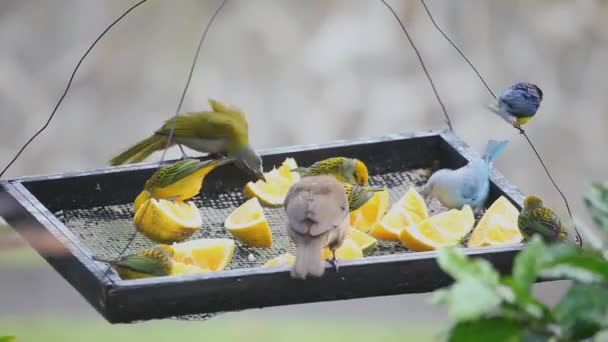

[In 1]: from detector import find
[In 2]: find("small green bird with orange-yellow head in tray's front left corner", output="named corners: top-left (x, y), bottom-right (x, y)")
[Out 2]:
top-left (93, 245), bottom-right (174, 279)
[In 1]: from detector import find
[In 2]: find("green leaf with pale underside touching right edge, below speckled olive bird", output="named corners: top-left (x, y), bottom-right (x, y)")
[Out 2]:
top-left (542, 254), bottom-right (608, 283)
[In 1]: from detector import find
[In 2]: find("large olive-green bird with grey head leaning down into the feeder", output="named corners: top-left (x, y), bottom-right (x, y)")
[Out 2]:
top-left (110, 99), bottom-right (264, 179)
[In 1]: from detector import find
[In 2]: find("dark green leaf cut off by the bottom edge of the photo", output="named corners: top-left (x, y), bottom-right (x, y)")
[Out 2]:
top-left (448, 318), bottom-right (522, 342)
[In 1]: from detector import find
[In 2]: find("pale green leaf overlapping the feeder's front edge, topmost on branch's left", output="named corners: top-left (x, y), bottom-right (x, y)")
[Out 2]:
top-left (438, 247), bottom-right (500, 285)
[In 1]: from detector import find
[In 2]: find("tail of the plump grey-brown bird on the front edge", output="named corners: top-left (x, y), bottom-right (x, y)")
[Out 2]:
top-left (291, 237), bottom-right (325, 279)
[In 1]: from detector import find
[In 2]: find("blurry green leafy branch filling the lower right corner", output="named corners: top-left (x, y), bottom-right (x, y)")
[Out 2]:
top-left (433, 183), bottom-right (608, 342)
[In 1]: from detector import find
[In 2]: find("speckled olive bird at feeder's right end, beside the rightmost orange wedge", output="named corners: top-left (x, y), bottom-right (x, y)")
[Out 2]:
top-left (517, 195), bottom-right (582, 246)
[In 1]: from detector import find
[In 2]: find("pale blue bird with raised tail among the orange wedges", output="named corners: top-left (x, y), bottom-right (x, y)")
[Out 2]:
top-left (420, 140), bottom-right (508, 209)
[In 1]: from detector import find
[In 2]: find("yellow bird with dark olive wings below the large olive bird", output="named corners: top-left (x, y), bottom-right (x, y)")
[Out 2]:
top-left (135, 157), bottom-right (235, 211)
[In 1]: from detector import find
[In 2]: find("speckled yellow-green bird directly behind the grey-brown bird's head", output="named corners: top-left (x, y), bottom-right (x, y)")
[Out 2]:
top-left (291, 157), bottom-right (369, 186)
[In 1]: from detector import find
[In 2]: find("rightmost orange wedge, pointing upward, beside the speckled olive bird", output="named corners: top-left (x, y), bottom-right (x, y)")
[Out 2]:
top-left (468, 196), bottom-right (523, 247)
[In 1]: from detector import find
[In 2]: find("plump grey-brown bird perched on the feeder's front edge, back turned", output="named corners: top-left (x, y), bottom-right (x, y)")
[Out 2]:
top-left (284, 175), bottom-right (350, 279)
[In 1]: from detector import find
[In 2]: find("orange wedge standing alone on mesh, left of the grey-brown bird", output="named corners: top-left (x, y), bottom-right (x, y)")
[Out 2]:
top-left (224, 197), bottom-right (272, 247)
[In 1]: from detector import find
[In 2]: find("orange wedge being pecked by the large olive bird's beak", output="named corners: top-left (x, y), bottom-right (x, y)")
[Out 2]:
top-left (243, 158), bottom-right (300, 207)
